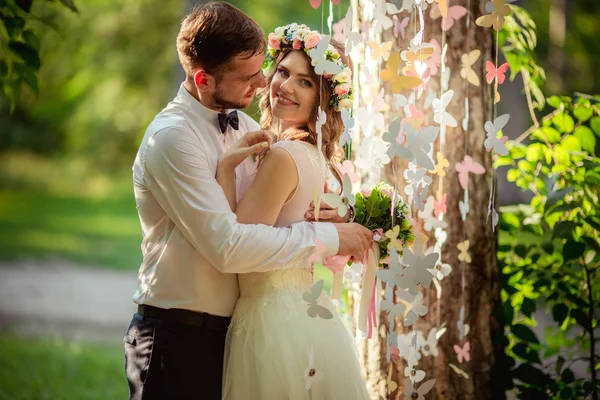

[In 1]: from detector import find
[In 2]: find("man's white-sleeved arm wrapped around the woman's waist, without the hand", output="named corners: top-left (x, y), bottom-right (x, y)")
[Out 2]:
top-left (145, 128), bottom-right (339, 273)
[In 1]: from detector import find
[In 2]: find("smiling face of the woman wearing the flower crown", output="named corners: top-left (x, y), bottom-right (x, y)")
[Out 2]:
top-left (269, 50), bottom-right (319, 129)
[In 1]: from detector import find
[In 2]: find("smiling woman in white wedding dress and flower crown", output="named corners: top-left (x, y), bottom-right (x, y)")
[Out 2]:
top-left (217, 24), bottom-right (368, 400)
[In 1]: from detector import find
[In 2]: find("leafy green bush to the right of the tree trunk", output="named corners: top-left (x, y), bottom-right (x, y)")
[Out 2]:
top-left (497, 96), bottom-right (600, 399)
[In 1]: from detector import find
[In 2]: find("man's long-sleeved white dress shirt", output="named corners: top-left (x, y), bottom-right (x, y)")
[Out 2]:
top-left (133, 85), bottom-right (339, 316)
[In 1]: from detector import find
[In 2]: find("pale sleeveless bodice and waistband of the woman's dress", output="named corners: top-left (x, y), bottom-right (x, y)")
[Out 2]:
top-left (238, 140), bottom-right (328, 299)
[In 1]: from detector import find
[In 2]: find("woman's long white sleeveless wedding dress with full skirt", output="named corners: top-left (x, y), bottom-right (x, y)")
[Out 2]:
top-left (223, 141), bottom-right (368, 400)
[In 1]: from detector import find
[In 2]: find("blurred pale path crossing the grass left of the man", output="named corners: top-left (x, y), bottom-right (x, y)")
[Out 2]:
top-left (0, 261), bottom-right (137, 343)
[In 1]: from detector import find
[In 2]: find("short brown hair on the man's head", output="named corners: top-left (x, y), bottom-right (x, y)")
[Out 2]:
top-left (177, 1), bottom-right (266, 77)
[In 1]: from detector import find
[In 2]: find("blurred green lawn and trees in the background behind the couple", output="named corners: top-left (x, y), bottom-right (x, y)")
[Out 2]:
top-left (0, 0), bottom-right (600, 399)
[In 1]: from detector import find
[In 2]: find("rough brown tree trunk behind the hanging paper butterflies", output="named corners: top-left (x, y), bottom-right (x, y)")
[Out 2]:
top-left (355, 0), bottom-right (504, 400)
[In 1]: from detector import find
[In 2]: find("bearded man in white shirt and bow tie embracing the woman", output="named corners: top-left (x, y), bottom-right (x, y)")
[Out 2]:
top-left (124, 2), bottom-right (372, 400)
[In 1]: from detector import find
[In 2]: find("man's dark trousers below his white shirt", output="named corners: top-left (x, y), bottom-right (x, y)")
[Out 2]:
top-left (123, 314), bottom-right (227, 400)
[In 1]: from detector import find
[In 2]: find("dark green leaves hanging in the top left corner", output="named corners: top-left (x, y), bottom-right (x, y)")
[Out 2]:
top-left (0, 0), bottom-right (77, 111)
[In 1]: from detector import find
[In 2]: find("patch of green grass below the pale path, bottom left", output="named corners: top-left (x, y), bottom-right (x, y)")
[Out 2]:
top-left (0, 334), bottom-right (128, 400)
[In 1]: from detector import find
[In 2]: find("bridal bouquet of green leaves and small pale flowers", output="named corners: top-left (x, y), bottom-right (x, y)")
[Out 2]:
top-left (354, 182), bottom-right (416, 260)
